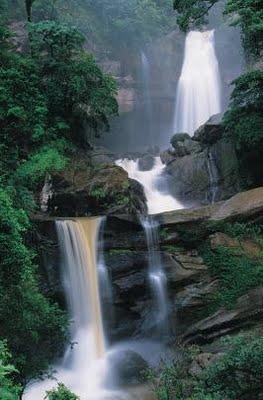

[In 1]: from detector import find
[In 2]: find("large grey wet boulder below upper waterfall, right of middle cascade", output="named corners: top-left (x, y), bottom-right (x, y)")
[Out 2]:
top-left (162, 114), bottom-right (240, 204)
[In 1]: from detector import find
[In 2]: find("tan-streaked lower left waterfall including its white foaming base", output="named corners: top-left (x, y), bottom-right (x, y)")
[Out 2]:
top-left (23, 218), bottom-right (134, 400)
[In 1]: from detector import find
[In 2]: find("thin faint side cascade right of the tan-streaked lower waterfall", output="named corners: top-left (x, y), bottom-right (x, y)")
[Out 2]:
top-left (141, 217), bottom-right (168, 334)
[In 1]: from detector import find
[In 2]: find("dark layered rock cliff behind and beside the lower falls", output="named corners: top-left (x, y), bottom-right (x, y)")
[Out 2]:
top-left (37, 188), bottom-right (263, 344)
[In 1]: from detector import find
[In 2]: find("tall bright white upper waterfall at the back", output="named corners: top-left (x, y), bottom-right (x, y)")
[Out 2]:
top-left (174, 30), bottom-right (221, 136)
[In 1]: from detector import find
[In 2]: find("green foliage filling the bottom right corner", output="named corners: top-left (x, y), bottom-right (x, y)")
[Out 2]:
top-left (149, 335), bottom-right (263, 400)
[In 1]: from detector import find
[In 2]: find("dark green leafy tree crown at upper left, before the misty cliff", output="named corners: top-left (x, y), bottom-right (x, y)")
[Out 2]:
top-left (30, 21), bottom-right (118, 143)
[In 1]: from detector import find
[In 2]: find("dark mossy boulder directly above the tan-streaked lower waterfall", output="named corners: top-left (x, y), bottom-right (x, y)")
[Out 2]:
top-left (48, 164), bottom-right (147, 217)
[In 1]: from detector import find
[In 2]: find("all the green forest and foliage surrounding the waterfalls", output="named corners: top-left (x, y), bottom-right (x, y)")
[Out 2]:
top-left (0, 0), bottom-right (263, 400)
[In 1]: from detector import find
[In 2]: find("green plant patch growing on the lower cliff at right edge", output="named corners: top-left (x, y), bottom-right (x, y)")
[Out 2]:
top-left (202, 247), bottom-right (263, 311)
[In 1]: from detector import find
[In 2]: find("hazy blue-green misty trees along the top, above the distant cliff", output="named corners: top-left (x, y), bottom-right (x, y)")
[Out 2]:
top-left (9, 0), bottom-right (175, 55)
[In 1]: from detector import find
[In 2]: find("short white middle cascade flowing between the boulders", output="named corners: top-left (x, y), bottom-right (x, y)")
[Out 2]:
top-left (116, 157), bottom-right (183, 214)
